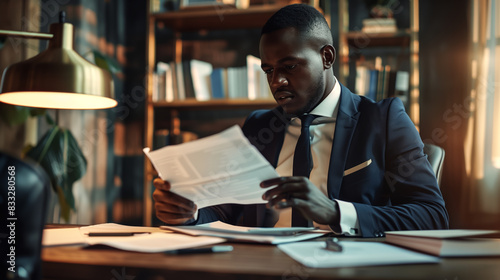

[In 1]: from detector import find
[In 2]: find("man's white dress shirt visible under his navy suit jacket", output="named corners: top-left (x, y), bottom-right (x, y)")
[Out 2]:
top-left (275, 79), bottom-right (360, 235)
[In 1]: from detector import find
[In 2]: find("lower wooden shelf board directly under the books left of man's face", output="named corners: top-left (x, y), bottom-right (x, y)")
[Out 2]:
top-left (153, 99), bottom-right (277, 110)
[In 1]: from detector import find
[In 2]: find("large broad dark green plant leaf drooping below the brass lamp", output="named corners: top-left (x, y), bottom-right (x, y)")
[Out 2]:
top-left (26, 126), bottom-right (87, 220)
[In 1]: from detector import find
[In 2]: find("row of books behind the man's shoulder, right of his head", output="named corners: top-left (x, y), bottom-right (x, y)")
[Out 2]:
top-left (354, 58), bottom-right (410, 105)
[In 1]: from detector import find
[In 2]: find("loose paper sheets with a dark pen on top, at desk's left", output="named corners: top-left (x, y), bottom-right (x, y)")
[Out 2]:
top-left (42, 223), bottom-right (226, 253)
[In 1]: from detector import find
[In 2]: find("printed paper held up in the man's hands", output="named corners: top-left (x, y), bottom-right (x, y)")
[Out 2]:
top-left (144, 125), bottom-right (279, 208)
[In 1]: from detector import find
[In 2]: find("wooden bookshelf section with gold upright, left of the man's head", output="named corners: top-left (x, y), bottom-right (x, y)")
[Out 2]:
top-left (143, 2), bottom-right (284, 226)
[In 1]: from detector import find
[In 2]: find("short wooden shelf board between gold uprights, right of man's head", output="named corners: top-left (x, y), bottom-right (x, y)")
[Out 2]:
top-left (345, 30), bottom-right (411, 48)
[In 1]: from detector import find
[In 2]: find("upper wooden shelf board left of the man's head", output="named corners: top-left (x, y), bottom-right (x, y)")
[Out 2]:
top-left (151, 5), bottom-right (282, 32)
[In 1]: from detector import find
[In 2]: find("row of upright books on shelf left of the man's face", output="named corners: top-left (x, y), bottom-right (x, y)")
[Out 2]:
top-left (153, 55), bottom-right (272, 102)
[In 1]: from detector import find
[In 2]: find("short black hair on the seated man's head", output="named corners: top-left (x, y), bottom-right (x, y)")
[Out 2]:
top-left (261, 4), bottom-right (331, 43)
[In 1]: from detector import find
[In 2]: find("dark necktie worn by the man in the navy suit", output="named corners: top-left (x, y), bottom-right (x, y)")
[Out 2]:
top-left (292, 115), bottom-right (316, 227)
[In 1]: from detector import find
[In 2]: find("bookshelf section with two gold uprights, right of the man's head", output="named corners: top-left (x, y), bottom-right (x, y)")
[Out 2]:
top-left (337, 0), bottom-right (420, 129)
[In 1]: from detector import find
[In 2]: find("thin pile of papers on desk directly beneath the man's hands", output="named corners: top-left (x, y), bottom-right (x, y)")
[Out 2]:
top-left (161, 221), bottom-right (329, 244)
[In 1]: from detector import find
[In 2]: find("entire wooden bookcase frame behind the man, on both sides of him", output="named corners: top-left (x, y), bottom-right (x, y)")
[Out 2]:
top-left (144, 0), bottom-right (420, 226)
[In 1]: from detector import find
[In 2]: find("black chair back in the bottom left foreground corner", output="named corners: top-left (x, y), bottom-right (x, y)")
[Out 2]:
top-left (0, 152), bottom-right (50, 279)
